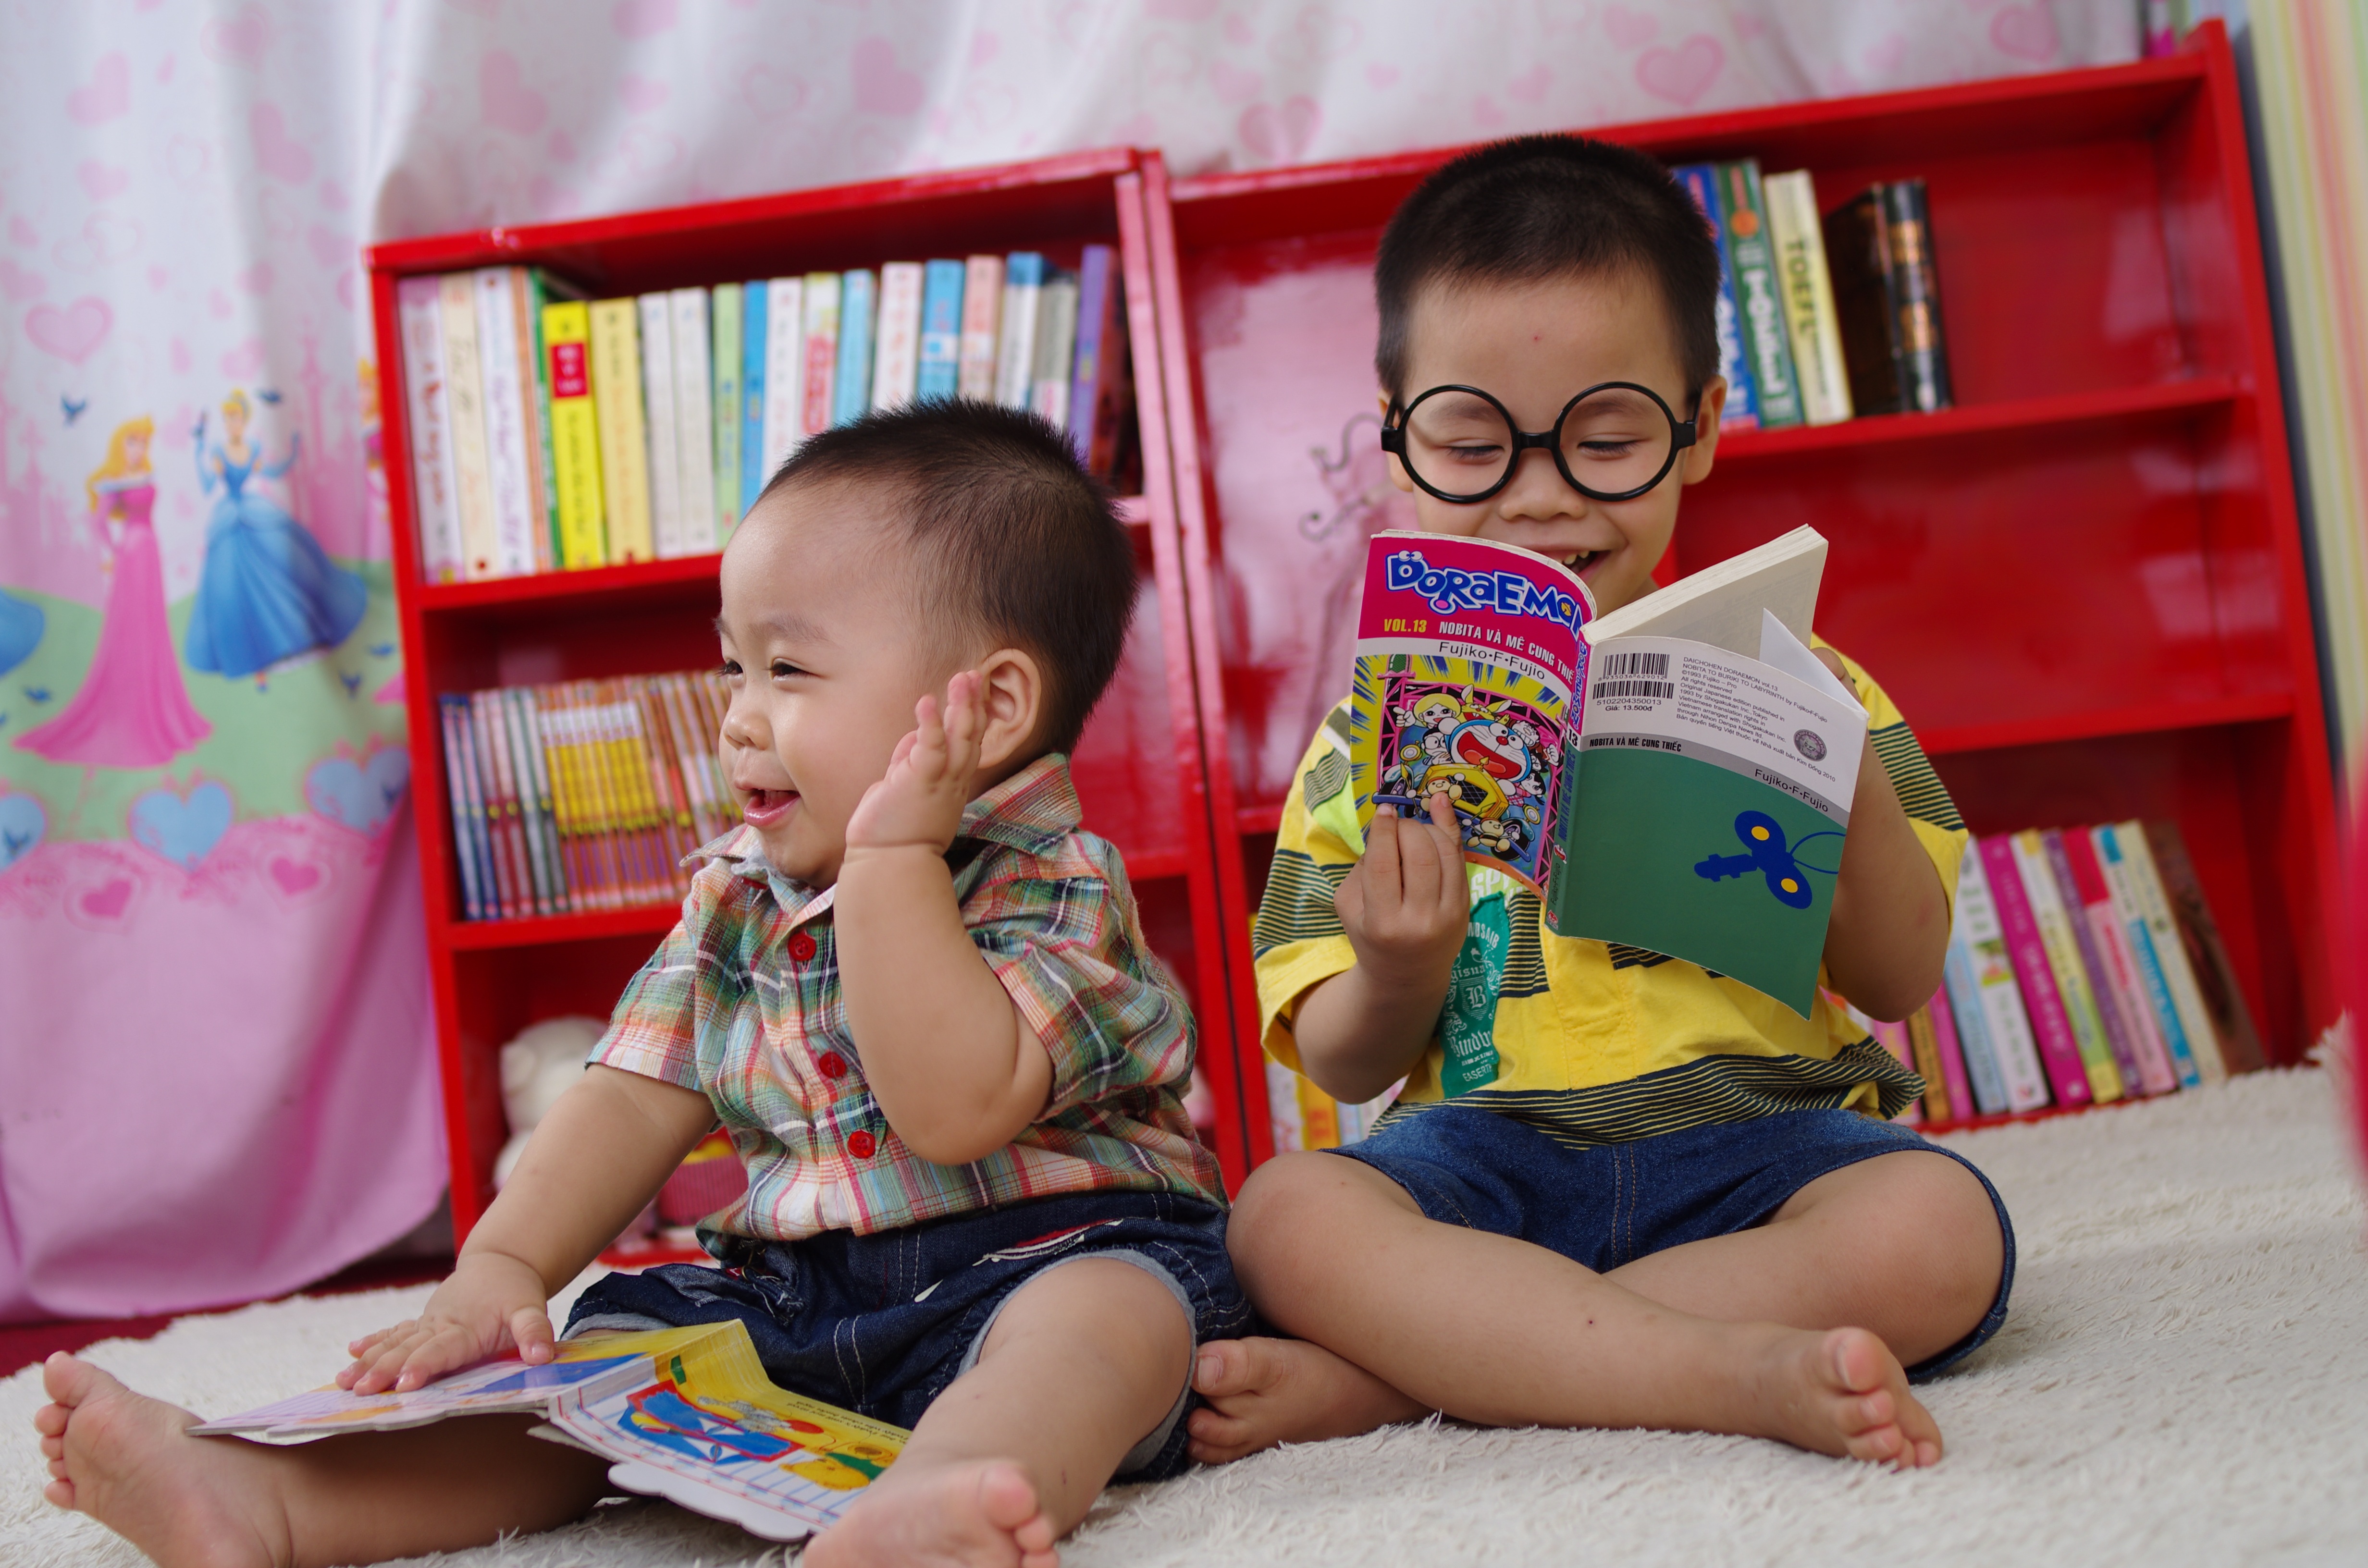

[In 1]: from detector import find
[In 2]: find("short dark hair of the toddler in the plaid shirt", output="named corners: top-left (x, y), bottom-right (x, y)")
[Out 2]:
top-left (760, 398), bottom-right (1136, 751)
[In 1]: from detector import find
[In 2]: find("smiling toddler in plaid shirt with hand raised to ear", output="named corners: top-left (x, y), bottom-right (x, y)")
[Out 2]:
top-left (36, 403), bottom-right (1248, 1568)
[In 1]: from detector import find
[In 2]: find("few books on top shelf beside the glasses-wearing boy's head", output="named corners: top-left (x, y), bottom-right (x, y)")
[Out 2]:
top-left (1674, 159), bottom-right (1954, 429)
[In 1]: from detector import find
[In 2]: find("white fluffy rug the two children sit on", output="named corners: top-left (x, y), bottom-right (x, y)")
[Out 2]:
top-left (0, 1071), bottom-right (2368, 1568)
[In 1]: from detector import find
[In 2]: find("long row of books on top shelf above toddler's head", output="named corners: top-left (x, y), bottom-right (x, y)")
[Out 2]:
top-left (395, 244), bottom-right (1136, 583)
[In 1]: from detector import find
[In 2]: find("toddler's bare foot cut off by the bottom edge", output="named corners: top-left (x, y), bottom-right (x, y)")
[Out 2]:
top-left (798, 1459), bottom-right (1061, 1568)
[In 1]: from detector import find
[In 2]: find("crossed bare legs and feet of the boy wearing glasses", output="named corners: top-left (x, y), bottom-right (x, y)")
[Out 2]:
top-left (1191, 1151), bottom-right (2006, 1464)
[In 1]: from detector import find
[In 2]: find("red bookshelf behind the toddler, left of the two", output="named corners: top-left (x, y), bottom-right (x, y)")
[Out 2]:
top-left (370, 149), bottom-right (1250, 1234)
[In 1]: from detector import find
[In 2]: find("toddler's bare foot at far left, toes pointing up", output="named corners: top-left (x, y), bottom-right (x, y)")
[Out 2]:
top-left (33, 1350), bottom-right (289, 1568)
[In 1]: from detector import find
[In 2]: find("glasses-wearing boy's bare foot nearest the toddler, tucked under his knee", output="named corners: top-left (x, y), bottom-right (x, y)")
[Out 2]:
top-left (1191, 1338), bottom-right (1431, 1464)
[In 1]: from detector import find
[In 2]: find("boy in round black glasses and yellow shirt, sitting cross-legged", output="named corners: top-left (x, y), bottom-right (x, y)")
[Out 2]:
top-left (1191, 137), bottom-right (2015, 1466)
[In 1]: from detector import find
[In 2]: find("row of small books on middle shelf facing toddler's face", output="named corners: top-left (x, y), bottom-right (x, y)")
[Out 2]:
top-left (436, 673), bottom-right (739, 919)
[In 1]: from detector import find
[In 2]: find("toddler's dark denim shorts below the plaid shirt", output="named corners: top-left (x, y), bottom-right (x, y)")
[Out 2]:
top-left (566, 1191), bottom-right (1250, 1481)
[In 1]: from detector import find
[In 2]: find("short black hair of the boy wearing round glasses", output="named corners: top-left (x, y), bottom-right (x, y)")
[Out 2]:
top-left (1373, 135), bottom-right (1719, 398)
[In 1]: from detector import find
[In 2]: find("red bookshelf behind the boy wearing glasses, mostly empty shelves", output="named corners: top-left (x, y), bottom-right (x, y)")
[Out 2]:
top-left (1146, 24), bottom-right (2337, 1156)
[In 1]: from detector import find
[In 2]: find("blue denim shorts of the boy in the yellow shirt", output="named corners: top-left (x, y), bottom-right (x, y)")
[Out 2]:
top-left (1329, 1104), bottom-right (2015, 1383)
